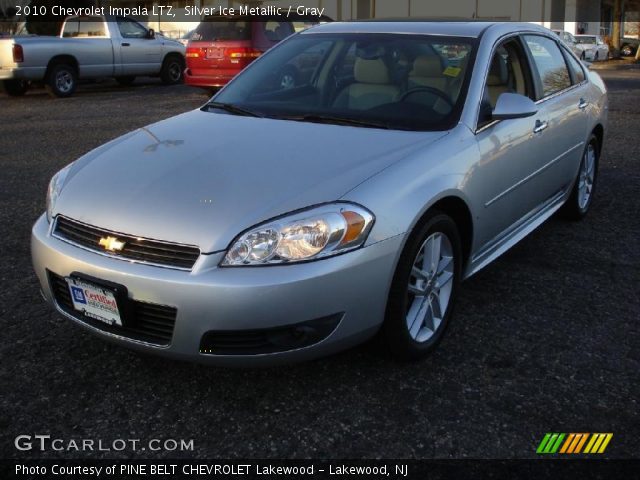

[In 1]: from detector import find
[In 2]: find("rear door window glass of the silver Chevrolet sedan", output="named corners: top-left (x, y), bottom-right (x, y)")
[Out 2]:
top-left (524, 35), bottom-right (571, 98)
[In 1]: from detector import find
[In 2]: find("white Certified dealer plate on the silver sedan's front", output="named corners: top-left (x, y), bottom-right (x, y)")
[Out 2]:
top-left (65, 277), bottom-right (122, 327)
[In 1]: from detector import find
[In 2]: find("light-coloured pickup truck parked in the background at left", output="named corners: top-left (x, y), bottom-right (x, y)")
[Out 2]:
top-left (0, 17), bottom-right (185, 97)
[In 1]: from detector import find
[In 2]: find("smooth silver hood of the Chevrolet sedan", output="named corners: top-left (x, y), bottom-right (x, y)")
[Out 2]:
top-left (53, 110), bottom-right (446, 252)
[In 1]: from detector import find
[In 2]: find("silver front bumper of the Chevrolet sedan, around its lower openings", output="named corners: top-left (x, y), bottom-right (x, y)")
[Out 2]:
top-left (31, 215), bottom-right (403, 366)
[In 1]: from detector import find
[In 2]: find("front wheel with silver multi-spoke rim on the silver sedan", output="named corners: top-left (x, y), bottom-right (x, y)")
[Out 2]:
top-left (380, 211), bottom-right (463, 360)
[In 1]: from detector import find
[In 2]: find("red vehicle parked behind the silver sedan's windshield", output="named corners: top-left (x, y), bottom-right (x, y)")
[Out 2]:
top-left (184, 16), bottom-right (330, 89)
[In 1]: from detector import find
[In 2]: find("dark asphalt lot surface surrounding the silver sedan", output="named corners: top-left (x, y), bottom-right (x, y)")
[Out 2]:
top-left (0, 70), bottom-right (640, 458)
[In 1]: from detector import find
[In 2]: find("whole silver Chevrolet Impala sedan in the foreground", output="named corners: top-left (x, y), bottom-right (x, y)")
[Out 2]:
top-left (32, 22), bottom-right (608, 365)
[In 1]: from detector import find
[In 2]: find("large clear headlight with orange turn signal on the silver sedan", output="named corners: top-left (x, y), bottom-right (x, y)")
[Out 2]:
top-left (221, 203), bottom-right (374, 267)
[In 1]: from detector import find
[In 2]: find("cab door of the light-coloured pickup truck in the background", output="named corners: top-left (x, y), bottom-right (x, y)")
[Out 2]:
top-left (113, 17), bottom-right (162, 75)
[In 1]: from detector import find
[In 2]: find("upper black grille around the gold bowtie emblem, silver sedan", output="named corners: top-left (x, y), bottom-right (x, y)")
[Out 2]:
top-left (53, 215), bottom-right (200, 270)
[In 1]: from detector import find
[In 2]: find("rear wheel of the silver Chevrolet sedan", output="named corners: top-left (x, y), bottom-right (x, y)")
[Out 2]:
top-left (562, 134), bottom-right (600, 220)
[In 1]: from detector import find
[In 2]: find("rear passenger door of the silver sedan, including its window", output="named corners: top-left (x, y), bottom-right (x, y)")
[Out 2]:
top-left (523, 35), bottom-right (588, 197)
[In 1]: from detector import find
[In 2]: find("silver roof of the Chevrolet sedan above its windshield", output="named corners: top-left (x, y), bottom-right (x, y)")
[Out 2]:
top-left (301, 19), bottom-right (549, 38)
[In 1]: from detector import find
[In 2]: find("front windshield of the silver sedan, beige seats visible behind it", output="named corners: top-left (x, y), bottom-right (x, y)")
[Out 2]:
top-left (210, 33), bottom-right (475, 130)
